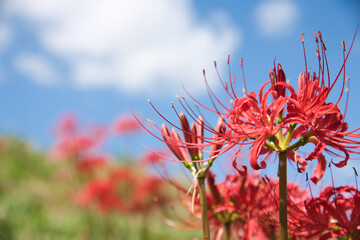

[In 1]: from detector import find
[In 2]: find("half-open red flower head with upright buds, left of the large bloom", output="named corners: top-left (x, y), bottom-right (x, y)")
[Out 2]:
top-left (140, 98), bottom-right (226, 177)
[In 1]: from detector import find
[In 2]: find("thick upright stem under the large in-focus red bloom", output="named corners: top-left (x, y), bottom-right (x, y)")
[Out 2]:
top-left (279, 152), bottom-right (288, 240)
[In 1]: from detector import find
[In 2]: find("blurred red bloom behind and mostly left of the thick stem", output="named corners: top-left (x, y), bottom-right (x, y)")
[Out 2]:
top-left (188, 172), bottom-right (308, 240)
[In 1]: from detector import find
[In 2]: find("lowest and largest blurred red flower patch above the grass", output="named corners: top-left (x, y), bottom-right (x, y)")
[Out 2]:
top-left (76, 168), bottom-right (167, 213)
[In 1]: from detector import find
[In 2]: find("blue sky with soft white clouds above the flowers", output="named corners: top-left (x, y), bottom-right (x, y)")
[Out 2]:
top-left (0, 0), bottom-right (360, 184)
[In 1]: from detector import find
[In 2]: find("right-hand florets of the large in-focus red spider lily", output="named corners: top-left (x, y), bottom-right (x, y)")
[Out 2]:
top-left (284, 29), bottom-right (360, 183)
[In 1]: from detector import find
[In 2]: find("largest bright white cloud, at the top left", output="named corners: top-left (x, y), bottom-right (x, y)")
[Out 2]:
top-left (3, 0), bottom-right (239, 94)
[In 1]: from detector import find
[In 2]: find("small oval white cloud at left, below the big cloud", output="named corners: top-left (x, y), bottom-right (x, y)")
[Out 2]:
top-left (14, 54), bottom-right (57, 86)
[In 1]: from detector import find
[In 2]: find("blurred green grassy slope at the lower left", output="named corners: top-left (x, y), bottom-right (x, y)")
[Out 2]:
top-left (0, 138), bottom-right (201, 240)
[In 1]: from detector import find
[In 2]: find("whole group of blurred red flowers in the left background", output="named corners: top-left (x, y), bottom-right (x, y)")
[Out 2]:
top-left (51, 115), bottom-right (168, 217)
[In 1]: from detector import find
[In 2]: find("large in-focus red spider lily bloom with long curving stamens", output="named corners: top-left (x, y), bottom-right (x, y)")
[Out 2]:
top-left (194, 27), bottom-right (360, 183)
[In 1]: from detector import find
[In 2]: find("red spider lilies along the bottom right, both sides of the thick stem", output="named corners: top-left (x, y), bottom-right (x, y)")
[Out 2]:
top-left (189, 172), bottom-right (360, 240)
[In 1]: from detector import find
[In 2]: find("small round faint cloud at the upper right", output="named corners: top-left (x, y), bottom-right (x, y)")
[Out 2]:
top-left (254, 0), bottom-right (299, 37)
